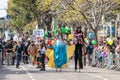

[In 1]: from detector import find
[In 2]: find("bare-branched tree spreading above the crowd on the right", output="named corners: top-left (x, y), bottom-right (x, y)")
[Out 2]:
top-left (61, 0), bottom-right (119, 42)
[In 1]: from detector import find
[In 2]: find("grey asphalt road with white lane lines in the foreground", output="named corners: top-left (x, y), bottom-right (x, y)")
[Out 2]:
top-left (0, 64), bottom-right (120, 80)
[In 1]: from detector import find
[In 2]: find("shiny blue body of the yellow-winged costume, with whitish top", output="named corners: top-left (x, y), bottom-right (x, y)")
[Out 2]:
top-left (54, 40), bottom-right (67, 68)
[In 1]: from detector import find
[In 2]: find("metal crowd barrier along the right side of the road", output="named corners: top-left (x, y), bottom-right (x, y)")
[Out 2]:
top-left (95, 52), bottom-right (120, 71)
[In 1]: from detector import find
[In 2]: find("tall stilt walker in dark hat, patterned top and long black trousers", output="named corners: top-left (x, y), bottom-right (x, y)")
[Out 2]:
top-left (74, 26), bottom-right (84, 71)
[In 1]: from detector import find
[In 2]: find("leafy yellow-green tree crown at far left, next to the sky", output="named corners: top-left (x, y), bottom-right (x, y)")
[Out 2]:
top-left (7, 0), bottom-right (34, 30)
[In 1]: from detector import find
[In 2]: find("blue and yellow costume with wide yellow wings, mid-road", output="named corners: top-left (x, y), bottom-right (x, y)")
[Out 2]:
top-left (46, 40), bottom-right (75, 68)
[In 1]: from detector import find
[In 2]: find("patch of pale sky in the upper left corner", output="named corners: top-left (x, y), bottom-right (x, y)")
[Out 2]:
top-left (0, 0), bottom-right (8, 18)
